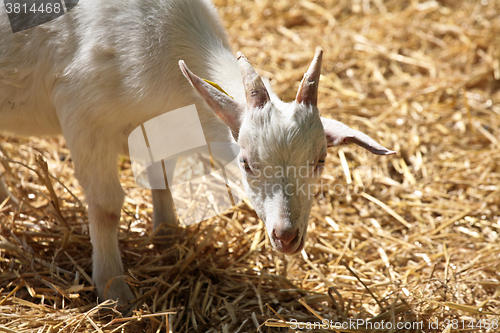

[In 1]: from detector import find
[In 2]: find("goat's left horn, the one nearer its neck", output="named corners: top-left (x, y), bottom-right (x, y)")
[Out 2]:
top-left (237, 52), bottom-right (269, 108)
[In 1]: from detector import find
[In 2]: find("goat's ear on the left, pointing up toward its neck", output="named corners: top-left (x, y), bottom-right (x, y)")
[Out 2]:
top-left (179, 60), bottom-right (245, 134)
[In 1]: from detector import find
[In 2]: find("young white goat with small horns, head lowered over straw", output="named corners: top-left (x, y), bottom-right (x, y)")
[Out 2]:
top-left (0, 0), bottom-right (394, 301)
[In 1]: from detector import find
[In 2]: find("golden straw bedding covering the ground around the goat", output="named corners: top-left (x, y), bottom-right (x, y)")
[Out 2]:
top-left (0, 0), bottom-right (500, 332)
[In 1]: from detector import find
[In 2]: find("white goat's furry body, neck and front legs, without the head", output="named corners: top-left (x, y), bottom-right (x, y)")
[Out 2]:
top-left (0, 0), bottom-right (244, 300)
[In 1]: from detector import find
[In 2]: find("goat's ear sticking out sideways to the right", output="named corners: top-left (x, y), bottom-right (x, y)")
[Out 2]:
top-left (321, 117), bottom-right (397, 155)
